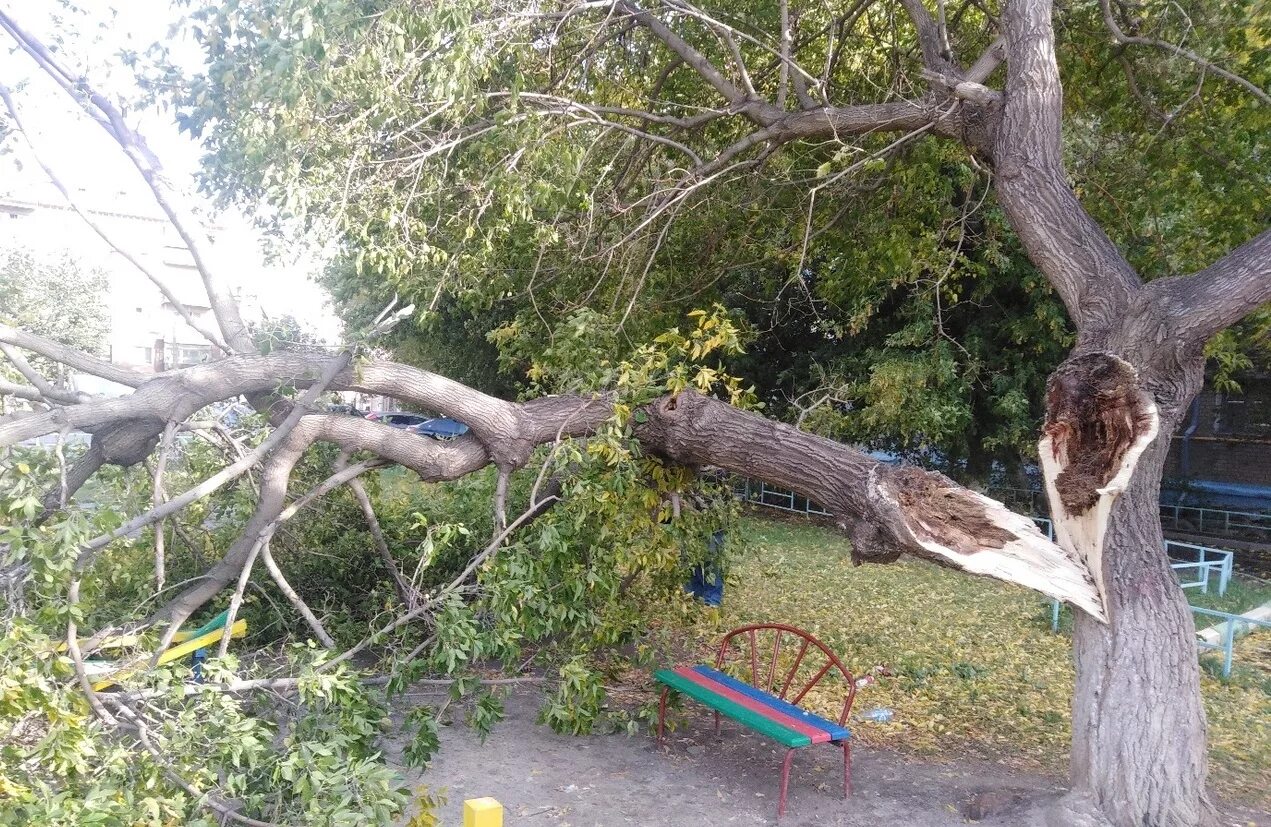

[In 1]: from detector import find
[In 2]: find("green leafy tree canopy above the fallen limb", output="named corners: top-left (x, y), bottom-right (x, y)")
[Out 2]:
top-left (174, 0), bottom-right (1271, 476)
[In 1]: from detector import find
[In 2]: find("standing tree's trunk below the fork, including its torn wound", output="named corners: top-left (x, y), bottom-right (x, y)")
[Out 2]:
top-left (1041, 337), bottom-right (1214, 827)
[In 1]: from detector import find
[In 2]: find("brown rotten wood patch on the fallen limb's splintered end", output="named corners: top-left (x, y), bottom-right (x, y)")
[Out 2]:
top-left (892, 467), bottom-right (1014, 554)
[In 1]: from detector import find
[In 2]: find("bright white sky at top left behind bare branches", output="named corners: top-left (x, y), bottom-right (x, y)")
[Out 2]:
top-left (0, 0), bottom-right (339, 340)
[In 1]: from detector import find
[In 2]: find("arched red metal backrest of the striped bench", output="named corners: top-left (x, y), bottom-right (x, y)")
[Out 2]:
top-left (716, 624), bottom-right (857, 725)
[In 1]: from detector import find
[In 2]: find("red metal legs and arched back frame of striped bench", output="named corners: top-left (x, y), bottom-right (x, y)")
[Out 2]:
top-left (657, 624), bottom-right (857, 818)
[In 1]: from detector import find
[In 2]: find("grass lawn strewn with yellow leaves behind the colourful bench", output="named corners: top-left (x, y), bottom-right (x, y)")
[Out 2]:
top-left (699, 517), bottom-right (1271, 807)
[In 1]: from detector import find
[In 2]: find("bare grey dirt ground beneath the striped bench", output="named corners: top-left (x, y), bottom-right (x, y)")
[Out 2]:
top-left (389, 691), bottom-right (1271, 827)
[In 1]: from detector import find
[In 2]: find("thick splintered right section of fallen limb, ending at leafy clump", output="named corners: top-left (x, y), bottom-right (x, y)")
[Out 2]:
top-left (637, 391), bottom-right (1103, 619)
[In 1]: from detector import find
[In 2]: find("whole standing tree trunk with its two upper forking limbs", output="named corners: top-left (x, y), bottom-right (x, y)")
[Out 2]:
top-left (994, 0), bottom-right (1245, 827)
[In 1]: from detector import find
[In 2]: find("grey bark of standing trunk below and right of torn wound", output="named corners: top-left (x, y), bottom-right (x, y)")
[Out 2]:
top-left (1051, 345), bottom-right (1215, 827)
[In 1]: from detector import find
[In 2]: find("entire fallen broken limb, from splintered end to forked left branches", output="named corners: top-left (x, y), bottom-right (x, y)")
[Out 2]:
top-left (0, 340), bottom-right (1103, 620)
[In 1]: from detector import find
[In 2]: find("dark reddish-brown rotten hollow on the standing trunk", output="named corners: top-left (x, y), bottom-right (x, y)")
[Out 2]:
top-left (1043, 353), bottom-right (1155, 514)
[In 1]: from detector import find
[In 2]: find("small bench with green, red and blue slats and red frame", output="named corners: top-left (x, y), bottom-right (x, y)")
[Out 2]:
top-left (653, 624), bottom-right (857, 818)
